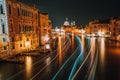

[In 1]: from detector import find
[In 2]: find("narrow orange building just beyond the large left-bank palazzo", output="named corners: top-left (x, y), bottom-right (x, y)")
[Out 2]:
top-left (39, 13), bottom-right (52, 45)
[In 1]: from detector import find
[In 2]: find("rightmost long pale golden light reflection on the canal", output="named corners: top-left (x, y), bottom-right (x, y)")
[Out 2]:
top-left (100, 38), bottom-right (105, 67)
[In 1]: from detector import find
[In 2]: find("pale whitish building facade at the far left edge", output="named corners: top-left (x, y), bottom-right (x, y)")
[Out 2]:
top-left (0, 0), bottom-right (10, 57)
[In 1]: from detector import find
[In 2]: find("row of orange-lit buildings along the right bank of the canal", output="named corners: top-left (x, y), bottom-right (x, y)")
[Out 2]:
top-left (86, 17), bottom-right (120, 40)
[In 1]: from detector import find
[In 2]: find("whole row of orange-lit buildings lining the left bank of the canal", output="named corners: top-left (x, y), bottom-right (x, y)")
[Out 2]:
top-left (0, 0), bottom-right (52, 57)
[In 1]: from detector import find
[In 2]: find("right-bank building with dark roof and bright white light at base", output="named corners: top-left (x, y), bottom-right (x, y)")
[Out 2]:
top-left (86, 19), bottom-right (110, 36)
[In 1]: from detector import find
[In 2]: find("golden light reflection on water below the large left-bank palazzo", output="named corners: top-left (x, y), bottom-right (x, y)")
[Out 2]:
top-left (25, 56), bottom-right (32, 78)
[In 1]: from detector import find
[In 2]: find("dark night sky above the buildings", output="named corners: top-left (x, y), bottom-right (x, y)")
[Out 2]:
top-left (20, 0), bottom-right (120, 27)
